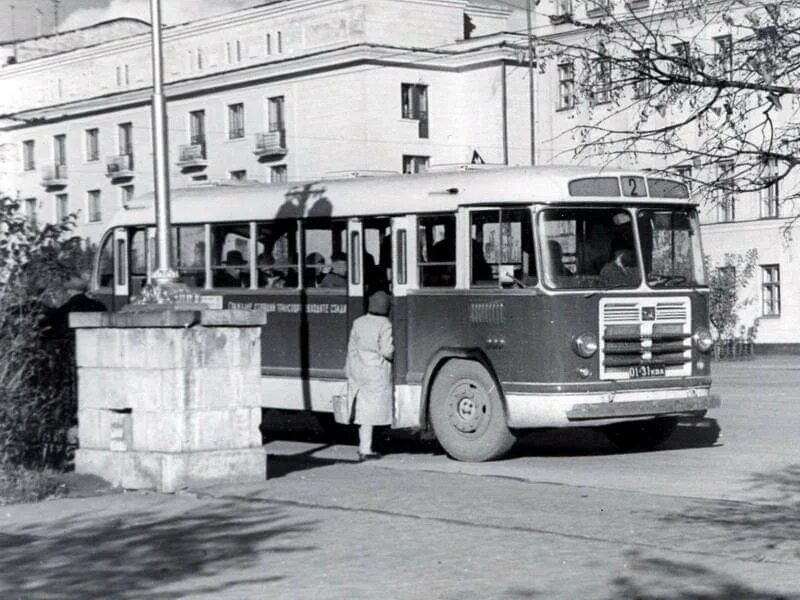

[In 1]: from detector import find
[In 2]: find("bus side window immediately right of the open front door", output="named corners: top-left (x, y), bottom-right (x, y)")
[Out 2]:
top-left (417, 215), bottom-right (456, 287)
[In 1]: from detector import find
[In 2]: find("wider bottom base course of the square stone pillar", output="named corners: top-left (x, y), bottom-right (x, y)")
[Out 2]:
top-left (75, 448), bottom-right (267, 493)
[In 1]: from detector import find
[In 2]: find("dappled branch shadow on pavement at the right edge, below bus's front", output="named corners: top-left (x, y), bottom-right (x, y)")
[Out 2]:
top-left (661, 464), bottom-right (800, 561)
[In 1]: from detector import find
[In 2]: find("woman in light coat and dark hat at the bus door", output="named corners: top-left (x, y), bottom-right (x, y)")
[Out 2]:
top-left (346, 292), bottom-right (394, 460)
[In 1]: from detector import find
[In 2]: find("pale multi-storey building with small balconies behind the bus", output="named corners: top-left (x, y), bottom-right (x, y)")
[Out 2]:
top-left (0, 0), bottom-right (800, 347)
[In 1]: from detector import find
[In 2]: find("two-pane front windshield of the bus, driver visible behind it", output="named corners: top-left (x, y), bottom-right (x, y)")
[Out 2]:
top-left (539, 207), bottom-right (705, 290)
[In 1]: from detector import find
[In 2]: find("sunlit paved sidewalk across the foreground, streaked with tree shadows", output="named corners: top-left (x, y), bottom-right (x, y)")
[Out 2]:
top-left (0, 456), bottom-right (800, 600)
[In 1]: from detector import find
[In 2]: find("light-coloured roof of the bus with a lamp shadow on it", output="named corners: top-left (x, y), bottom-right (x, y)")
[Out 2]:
top-left (104, 166), bottom-right (693, 227)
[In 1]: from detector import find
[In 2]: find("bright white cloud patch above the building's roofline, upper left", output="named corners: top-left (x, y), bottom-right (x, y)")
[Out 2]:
top-left (59, 0), bottom-right (264, 31)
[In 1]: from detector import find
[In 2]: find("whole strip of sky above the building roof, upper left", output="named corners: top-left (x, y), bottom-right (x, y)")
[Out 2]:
top-left (0, 0), bottom-right (264, 40)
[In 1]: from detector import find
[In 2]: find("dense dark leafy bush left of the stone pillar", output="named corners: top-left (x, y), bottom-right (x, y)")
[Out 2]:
top-left (0, 197), bottom-right (93, 468)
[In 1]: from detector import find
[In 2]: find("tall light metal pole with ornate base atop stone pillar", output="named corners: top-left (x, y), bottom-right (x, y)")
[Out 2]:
top-left (150, 0), bottom-right (178, 286)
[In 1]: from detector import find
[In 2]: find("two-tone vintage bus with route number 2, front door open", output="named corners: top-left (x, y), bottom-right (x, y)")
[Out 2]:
top-left (93, 167), bottom-right (719, 461)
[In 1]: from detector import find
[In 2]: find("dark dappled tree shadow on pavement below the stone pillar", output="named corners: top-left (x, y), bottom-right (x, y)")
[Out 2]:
top-left (0, 502), bottom-right (315, 600)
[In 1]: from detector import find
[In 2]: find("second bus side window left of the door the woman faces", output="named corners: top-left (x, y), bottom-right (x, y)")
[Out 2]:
top-left (256, 221), bottom-right (300, 289)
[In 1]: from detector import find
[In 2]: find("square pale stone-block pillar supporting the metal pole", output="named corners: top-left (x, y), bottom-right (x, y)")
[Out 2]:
top-left (70, 310), bottom-right (266, 492)
